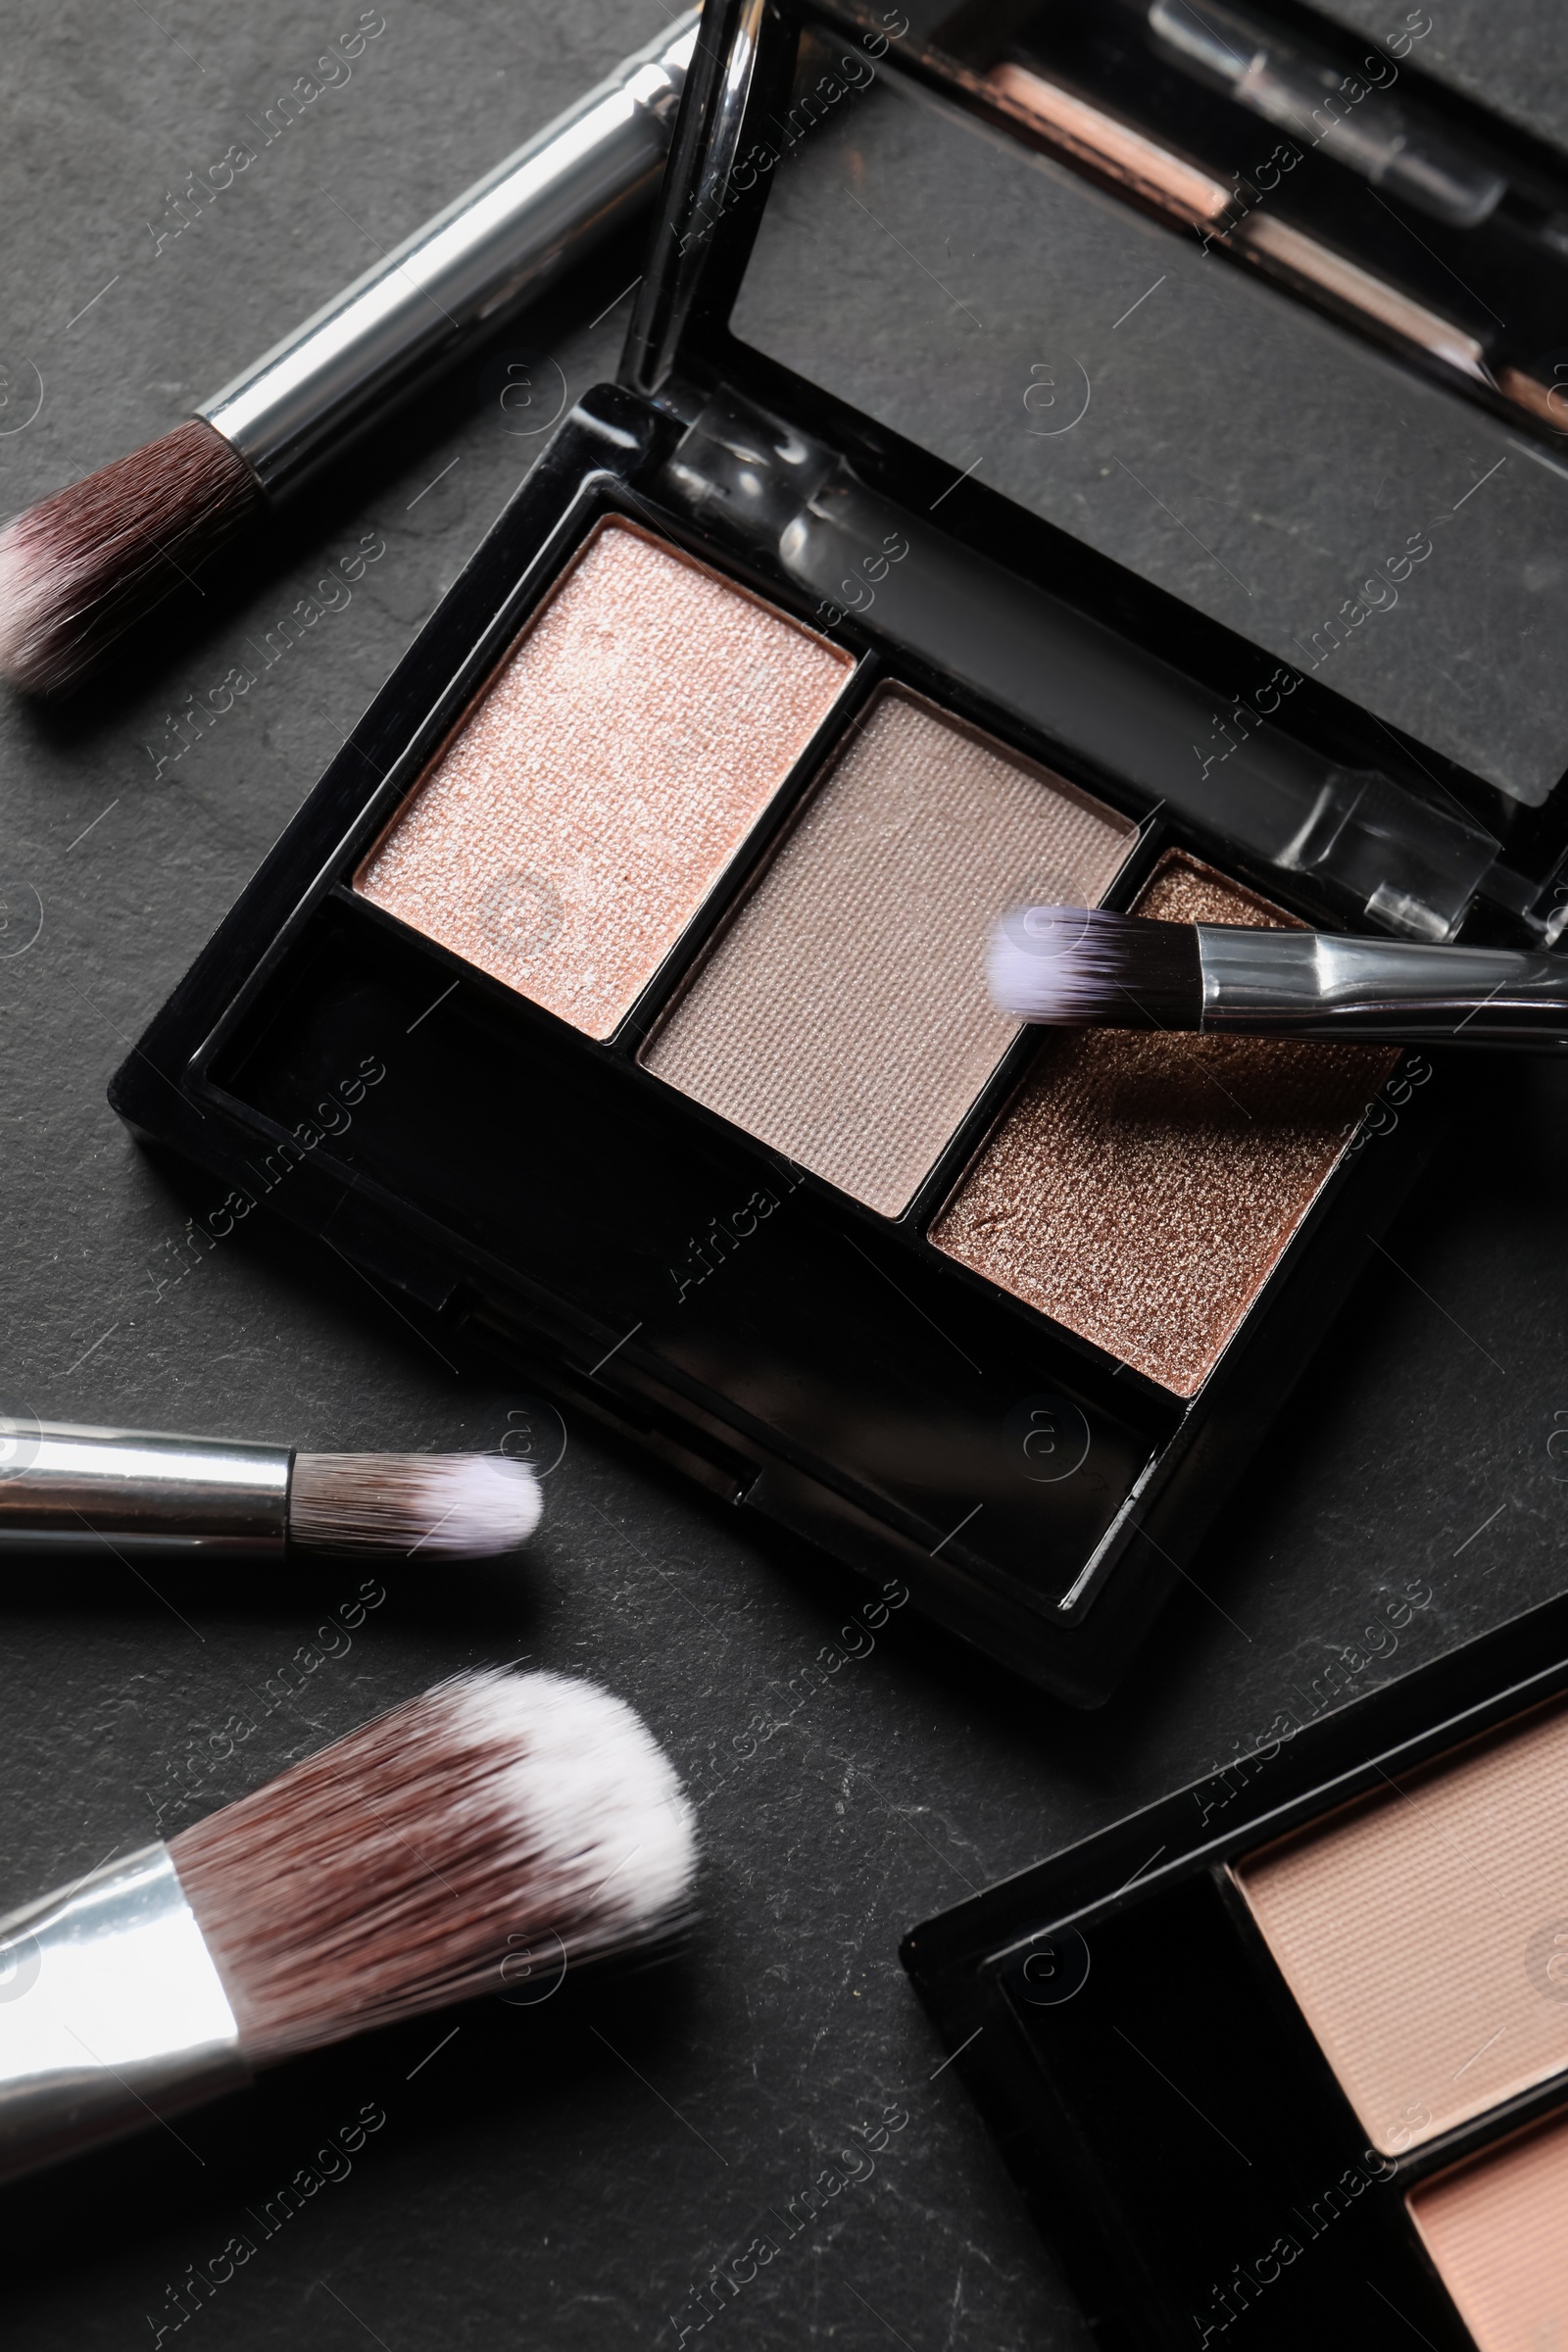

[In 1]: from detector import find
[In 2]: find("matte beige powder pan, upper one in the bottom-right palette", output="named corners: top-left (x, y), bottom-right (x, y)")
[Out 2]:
top-left (1237, 1707), bottom-right (1568, 2154)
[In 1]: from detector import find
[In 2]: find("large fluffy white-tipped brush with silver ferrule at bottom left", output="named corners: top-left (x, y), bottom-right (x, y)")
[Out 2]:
top-left (0, 1668), bottom-right (696, 2178)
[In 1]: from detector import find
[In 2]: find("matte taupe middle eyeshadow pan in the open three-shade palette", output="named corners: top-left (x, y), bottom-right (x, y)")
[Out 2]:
top-left (644, 689), bottom-right (1133, 1216)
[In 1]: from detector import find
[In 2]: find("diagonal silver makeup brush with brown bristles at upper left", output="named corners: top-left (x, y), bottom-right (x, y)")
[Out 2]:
top-left (0, 10), bottom-right (698, 692)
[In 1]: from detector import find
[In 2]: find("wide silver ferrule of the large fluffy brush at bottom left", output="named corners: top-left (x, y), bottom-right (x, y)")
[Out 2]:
top-left (0, 1844), bottom-right (249, 2180)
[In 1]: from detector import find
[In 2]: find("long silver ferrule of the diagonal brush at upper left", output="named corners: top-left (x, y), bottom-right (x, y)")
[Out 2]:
top-left (195, 10), bottom-right (698, 499)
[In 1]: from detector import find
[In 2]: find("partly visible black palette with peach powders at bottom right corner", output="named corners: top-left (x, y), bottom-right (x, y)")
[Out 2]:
top-left (906, 1594), bottom-right (1568, 2352)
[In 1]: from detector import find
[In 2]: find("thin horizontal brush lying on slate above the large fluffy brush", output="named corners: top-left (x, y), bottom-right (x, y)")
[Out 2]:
top-left (0, 1418), bottom-right (543, 1559)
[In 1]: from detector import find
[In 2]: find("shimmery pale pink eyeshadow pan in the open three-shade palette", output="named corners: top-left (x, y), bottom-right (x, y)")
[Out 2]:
top-left (358, 522), bottom-right (854, 1037)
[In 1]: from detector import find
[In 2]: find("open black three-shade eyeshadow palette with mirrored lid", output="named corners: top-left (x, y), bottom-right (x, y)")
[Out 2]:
top-left (113, 0), bottom-right (1568, 1705)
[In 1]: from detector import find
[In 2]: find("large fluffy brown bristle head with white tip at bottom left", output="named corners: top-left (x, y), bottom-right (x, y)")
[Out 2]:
top-left (170, 1668), bottom-right (696, 2065)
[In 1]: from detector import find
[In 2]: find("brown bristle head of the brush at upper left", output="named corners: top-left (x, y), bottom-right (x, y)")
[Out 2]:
top-left (0, 418), bottom-right (261, 694)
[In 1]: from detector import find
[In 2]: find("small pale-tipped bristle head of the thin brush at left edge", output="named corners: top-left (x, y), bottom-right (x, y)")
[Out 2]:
top-left (289, 1453), bottom-right (543, 1559)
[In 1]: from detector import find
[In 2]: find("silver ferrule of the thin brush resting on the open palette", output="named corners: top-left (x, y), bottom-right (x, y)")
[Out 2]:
top-left (1197, 922), bottom-right (1568, 1049)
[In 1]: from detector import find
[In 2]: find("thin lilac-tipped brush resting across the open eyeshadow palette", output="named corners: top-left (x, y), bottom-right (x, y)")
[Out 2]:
top-left (987, 906), bottom-right (1568, 1052)
